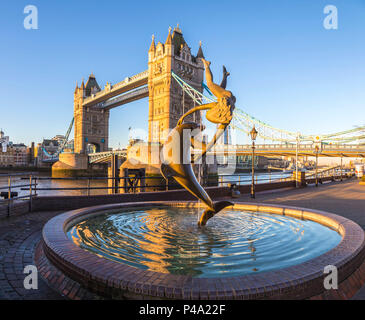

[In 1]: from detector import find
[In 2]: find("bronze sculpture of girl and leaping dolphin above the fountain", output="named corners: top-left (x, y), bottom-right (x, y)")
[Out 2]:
top-left (161, 58), bottom-right (236, 226)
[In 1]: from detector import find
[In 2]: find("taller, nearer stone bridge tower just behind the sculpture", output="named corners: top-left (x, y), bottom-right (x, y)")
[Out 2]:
top-left (148, 25), bottom-right (204, 144)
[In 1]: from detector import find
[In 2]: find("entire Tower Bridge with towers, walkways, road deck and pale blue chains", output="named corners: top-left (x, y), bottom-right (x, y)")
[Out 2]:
top-left (52, 26), bottom-right (365, 175)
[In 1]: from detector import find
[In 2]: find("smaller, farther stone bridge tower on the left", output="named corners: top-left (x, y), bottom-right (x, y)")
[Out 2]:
top-left (74, 74), bottom-right (109, 154)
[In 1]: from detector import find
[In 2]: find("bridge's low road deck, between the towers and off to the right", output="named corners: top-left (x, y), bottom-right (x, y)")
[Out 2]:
top-left (88, 144), bottom-right (365, 163)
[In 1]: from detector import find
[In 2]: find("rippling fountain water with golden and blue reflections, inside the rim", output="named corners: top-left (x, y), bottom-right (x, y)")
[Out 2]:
top-left (68, 208), bottom-right (341, 277)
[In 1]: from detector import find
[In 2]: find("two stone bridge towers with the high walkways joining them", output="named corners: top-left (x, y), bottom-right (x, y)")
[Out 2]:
top-left (53, 26), bottom-right (208, 175)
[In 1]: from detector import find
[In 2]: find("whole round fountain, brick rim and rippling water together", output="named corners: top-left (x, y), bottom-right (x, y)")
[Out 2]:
top-left (42, 202), bottom-right (364, 299)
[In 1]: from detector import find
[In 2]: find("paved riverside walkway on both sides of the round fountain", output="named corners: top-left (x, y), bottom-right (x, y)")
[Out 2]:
top-left (0, 179), bottom-right (365, 300)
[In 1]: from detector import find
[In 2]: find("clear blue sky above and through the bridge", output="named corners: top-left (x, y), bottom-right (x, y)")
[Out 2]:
top-left (0, 0), bottom-right (365, 147)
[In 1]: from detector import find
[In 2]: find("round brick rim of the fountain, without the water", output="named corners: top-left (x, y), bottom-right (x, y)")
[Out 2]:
top-left (43, 202), bottom-right (364, 299)
